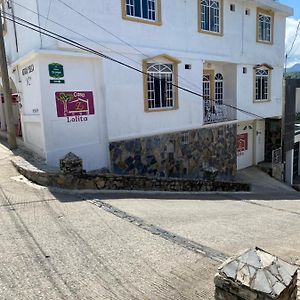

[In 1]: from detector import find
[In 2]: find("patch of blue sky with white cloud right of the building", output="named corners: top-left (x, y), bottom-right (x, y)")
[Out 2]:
top-left (280, 0), bottom-right (300, 67)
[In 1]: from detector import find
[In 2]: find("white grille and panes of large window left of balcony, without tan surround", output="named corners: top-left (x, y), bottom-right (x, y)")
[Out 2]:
top-left (147, 63), bottom-right (175, 110)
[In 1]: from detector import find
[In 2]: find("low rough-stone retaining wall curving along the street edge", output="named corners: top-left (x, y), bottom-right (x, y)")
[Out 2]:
top-left (12, 159), bottom-right (250, 192)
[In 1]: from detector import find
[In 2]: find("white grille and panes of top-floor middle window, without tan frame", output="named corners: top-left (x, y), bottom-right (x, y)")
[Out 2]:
top-left (201, 0), bottom-right (221, 33)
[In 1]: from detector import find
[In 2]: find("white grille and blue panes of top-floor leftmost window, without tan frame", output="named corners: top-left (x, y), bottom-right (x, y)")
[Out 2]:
top-left (126, 0), bottom-right (157, 21)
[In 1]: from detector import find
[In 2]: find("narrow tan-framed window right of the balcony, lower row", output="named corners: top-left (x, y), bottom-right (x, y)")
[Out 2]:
top-left (254, 65), bottom-right (272, 101)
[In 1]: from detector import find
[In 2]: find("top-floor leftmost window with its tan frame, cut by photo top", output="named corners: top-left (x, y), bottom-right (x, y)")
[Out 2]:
top-left (122, 0), bottom-right (161, 25)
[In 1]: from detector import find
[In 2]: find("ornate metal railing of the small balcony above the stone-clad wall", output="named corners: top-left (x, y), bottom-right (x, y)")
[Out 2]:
top-left (204, 100), bottom-right (236, 124)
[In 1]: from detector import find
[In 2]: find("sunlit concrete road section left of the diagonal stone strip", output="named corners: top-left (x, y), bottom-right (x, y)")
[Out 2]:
top-left (0, 146), bottom-right (219, 300)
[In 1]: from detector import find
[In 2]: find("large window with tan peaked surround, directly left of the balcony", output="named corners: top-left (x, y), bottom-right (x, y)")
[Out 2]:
top-left (144, 56), bottom-right (178, 111)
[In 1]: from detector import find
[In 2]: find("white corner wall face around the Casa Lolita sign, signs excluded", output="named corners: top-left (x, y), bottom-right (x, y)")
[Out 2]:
top-left (39, 54), bottom-right (109, 170)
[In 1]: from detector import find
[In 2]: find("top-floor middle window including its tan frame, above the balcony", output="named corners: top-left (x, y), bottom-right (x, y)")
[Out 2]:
top-left (199, 0), bottom-right (223, 35)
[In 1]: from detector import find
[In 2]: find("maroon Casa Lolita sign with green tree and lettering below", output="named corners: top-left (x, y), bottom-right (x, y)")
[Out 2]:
top-left (55, 92), bottom-right (95, 123)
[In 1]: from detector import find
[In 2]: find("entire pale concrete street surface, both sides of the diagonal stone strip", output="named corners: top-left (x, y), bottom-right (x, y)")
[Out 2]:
top-left (0, 141), bottom-right (300, 300)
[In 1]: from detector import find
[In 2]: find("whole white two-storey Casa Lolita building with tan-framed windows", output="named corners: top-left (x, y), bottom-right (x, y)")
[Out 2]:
top-left (0, 0), bottom-right (293, 177)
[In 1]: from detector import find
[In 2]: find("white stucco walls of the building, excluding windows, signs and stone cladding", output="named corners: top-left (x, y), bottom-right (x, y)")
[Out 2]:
top-left (0, 0), bottom-right (291, 169)
